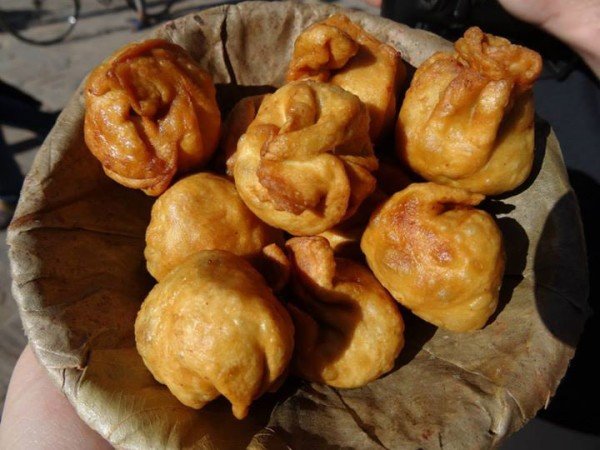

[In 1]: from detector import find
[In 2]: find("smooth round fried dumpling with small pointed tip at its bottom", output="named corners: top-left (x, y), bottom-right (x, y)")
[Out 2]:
top-left (135, 250), bottom-right (294, 419)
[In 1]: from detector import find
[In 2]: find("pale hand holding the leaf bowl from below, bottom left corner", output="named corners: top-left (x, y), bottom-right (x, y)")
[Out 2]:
top-left (0, 346), bottom-right (112, 450)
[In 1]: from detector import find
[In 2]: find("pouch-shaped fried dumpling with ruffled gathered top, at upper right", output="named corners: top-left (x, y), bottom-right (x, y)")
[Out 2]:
top-left (396, 28), bottom-right (542, 195)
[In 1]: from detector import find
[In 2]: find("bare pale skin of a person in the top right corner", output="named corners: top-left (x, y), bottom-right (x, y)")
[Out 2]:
top-left (498, 0), bottom-right (600, 77)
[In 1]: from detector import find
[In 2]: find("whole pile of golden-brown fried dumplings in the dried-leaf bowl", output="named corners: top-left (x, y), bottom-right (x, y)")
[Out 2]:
top-left (85, 15), bottom-right (540, 419)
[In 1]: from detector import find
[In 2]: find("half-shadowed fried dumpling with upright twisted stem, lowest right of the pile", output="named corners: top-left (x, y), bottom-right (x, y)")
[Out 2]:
top-left (286, 236), bottom-right (404, 388)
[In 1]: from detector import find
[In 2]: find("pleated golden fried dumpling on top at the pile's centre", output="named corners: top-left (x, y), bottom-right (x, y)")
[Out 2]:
top-left (233, 81), bottom-right (377, 235)
